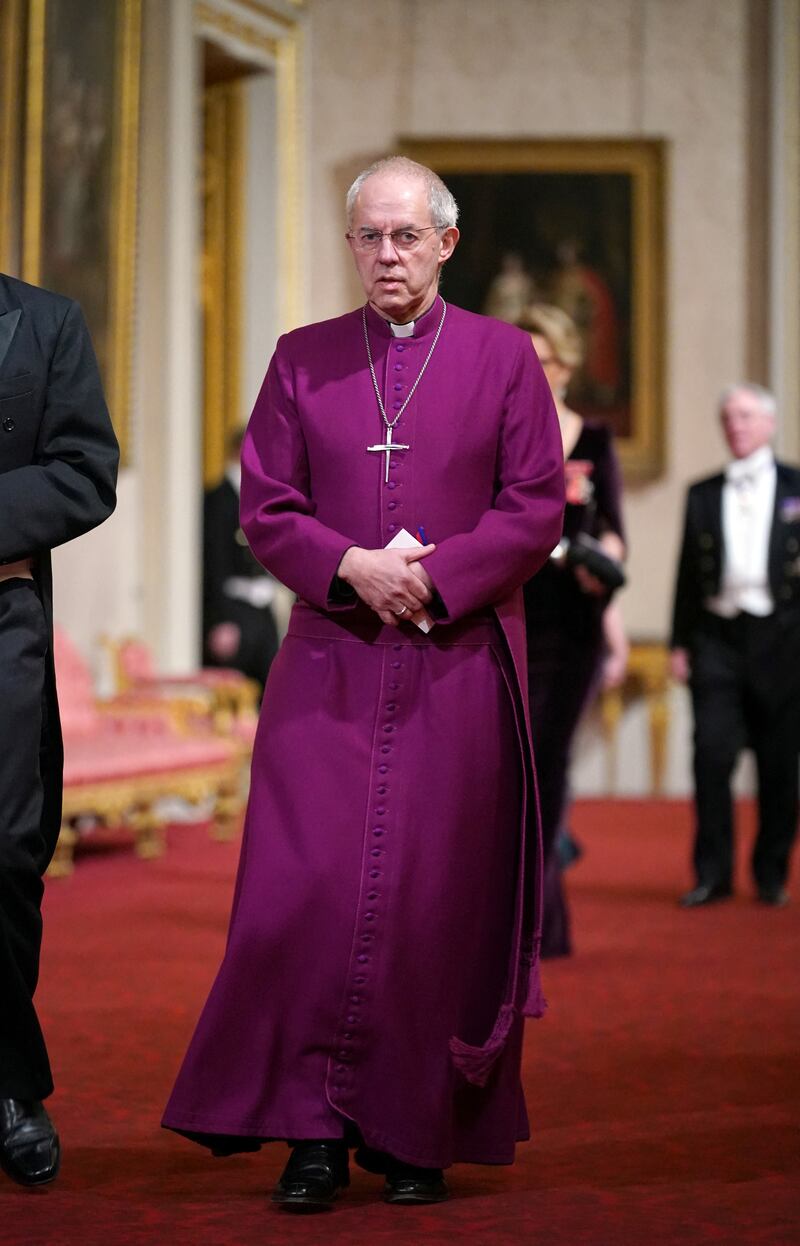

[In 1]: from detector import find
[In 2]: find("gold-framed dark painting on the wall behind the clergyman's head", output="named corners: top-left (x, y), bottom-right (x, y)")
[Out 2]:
top-left (399, 138), bottom-right (665, 481)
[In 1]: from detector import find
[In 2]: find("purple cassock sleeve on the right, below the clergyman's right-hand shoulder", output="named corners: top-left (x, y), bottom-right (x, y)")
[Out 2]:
top-left (425, 335), bottom-right (564, 623)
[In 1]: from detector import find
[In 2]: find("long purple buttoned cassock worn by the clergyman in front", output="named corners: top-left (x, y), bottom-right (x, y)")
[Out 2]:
top-left (163, 298), bottom-right (564, 1168)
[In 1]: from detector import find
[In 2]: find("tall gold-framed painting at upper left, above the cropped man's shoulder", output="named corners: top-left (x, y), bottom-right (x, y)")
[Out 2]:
top-left (22, 0), bottom-right (142, 464)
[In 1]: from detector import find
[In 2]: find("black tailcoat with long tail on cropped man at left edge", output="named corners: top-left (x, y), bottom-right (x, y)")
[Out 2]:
top-left (0, 273), bottom-right (120, 846)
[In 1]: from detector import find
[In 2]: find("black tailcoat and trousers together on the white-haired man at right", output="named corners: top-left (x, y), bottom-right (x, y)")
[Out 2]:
top-left (672, 464), bottom-right (800, 895)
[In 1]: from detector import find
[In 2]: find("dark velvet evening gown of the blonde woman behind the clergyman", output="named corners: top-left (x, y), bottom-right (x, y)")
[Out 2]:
top-left (525, 421), bottom-right (624, 957)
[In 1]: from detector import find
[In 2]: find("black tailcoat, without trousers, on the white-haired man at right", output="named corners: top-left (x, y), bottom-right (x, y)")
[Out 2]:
top-left (670, 462), bottom-right (800, 649)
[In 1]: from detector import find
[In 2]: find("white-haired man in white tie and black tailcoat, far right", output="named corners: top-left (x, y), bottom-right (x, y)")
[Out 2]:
top-left (672, 383), bottom-right (800, 908)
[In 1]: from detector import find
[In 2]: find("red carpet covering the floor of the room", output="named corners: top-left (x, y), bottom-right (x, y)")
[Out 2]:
top-left (0, 801), bottom-right (800, 1246)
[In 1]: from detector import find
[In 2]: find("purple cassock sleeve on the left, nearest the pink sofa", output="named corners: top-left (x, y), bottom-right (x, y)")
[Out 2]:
top-left (240, 338), bottom-right (356, 609)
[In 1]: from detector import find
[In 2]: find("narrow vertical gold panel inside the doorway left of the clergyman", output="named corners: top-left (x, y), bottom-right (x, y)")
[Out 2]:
top-left (202, 81), bottom-right (245, 487)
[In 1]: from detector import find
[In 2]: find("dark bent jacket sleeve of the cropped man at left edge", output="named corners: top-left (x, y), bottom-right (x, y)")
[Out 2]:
top-left (0, 303), bottom-right (120, 562)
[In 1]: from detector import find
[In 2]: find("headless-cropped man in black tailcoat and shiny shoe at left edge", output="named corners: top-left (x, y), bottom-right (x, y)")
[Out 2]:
top-left (0, 274), bottom-right (118, 1185)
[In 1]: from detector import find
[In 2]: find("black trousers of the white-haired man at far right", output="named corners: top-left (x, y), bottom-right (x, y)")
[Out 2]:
top-left (690, 613), bottom-right (800, 888)
